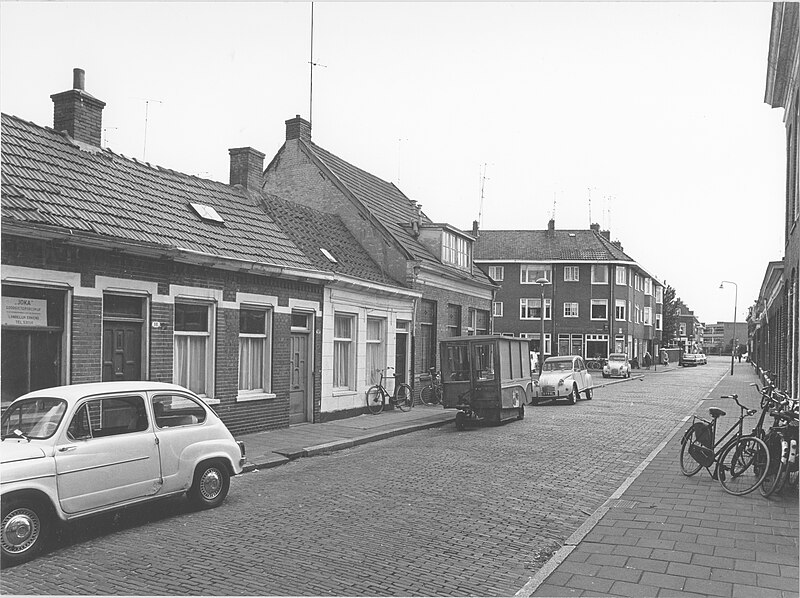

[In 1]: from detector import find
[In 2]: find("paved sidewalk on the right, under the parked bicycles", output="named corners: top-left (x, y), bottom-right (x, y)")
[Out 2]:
top-left (517, 364), bottom-right (800, 598)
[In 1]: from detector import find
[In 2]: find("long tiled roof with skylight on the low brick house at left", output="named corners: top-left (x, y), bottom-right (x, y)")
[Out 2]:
top-left (1, 114), bottom-right (313, 269)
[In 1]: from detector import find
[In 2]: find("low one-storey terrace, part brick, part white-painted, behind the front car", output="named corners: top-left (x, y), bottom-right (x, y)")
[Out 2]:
top-left (2, 69), bottom-right (422, 434)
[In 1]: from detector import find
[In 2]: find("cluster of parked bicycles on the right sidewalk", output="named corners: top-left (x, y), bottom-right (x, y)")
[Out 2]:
top-left (680, 383), bottom-right (798, 497)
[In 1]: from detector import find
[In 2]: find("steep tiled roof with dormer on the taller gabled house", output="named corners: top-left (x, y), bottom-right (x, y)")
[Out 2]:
top-left (301, 142), bottom-right (489, 283)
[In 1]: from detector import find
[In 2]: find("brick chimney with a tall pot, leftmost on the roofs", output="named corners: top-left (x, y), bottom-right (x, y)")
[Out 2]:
top-left (50, 68), bottom-right (106, 147)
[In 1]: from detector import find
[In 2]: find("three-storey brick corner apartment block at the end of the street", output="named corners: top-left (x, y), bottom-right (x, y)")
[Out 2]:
top-left (472, 220), bottom-right (663, 360)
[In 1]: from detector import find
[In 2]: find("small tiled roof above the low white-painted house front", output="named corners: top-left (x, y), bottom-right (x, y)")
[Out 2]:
top-left (264, 195), bottom-right (399, 286)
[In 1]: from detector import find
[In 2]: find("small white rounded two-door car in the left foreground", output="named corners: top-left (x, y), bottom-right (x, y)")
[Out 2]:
top-left (0, 382), bottom-right (245, 565)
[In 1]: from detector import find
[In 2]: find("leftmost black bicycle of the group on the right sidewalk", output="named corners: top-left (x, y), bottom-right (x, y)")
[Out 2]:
top-left (680, 394), bottom-right (770, 496)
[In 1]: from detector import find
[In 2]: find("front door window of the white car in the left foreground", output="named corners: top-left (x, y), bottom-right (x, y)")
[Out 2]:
top-left (67, 396), bottom-right (149, 440)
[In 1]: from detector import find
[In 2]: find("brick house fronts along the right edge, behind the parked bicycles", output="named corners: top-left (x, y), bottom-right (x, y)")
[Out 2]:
top-left (748, 2), bottom-right (800, 398)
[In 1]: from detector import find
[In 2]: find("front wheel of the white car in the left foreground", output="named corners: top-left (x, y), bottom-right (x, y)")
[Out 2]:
top-left (0, 498), bottom-right (51, 566)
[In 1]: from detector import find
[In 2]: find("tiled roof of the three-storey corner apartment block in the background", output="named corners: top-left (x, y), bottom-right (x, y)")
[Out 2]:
top-left (474, 230), bottom-right (634, 262)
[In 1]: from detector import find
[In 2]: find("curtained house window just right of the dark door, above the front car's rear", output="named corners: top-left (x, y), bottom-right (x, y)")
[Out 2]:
top-left (173, 303), bottom-right (214, 396)
